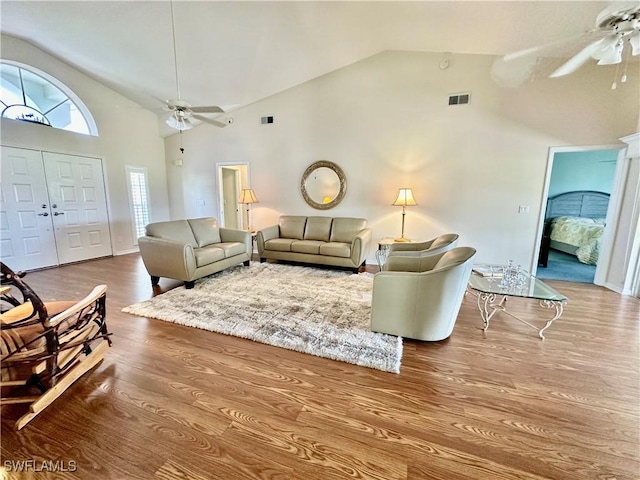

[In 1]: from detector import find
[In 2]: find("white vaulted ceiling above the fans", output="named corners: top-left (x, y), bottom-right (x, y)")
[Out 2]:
top-left (0, 0), bottom-right (607, 132)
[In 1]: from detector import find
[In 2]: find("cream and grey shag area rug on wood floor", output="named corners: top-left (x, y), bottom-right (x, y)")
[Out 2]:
top-left (122, 263), bottom-right (402, 373)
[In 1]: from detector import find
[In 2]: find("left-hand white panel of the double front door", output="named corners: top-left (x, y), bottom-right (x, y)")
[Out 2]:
top-left (0, 147), bottom-right (58, 271)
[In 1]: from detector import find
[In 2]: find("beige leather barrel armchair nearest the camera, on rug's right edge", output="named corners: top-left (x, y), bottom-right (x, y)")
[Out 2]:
top-left (371, 247), bottom-right (476, 341)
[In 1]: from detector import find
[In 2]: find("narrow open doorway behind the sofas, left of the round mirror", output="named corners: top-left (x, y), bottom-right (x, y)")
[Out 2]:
top-left (216, 162), bottom-right (249, 230)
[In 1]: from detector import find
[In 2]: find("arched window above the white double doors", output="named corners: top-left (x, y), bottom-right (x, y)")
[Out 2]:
top-left (0, 60), bottom-right (98, 136)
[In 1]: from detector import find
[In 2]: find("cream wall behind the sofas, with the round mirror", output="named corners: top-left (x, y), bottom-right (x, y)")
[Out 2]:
top-left (165, 52), bottom-right (639, 265)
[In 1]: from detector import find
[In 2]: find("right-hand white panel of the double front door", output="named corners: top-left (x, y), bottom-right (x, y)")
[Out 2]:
top-left (42, 152), bottom-right (112, 264)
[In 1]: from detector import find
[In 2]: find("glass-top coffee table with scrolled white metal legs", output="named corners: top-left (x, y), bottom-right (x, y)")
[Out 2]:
top-left (469, 264), bottom-right (568, 340)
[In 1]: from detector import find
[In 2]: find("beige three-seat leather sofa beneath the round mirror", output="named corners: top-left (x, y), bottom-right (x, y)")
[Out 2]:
top-left (257, 215), bottom-right (371, 271)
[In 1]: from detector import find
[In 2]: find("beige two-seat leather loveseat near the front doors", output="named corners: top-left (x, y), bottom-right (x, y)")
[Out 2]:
top-left (138, 217), bottom-right (253, 288)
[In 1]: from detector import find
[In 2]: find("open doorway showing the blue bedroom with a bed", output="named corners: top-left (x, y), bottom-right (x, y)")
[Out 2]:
top-left (536, 146), bottom-right (621, 283)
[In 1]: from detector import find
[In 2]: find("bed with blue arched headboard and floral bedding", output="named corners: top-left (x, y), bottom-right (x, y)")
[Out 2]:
top-left (540, 190), bottom-right (609, 267)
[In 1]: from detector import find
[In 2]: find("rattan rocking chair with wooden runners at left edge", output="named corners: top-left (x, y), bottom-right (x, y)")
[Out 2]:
top-left (0, 262), bottom-right (111, 430)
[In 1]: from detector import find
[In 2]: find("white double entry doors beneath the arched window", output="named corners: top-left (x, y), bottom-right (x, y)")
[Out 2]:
top-left (0, 147), bottom-right (112, 270)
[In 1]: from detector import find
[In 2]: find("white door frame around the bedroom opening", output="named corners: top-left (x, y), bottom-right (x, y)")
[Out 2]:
top-left (530, 144), bottom-right (626, 286)
